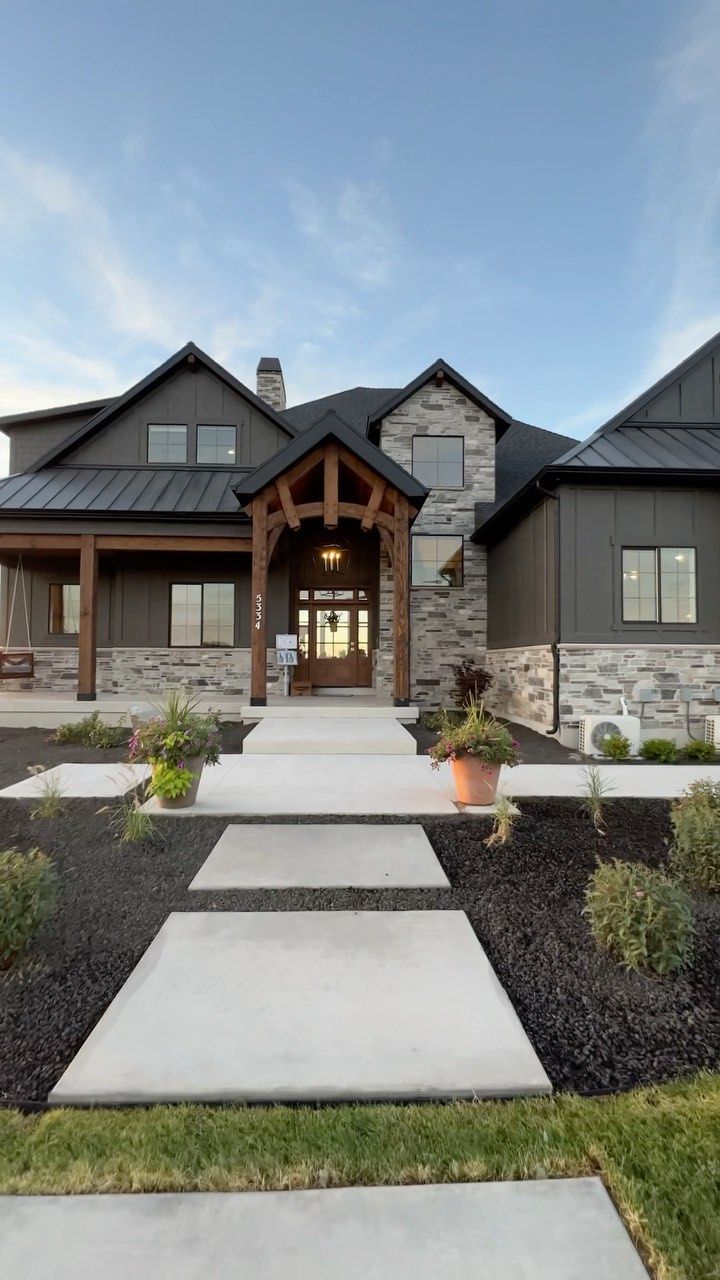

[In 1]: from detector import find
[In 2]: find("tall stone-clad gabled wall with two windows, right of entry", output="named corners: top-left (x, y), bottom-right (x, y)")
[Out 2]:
top-left (375, 380), bottom-right (495, 705)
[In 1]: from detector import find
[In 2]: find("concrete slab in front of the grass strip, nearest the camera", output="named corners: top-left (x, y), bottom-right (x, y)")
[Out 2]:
top-left (0, 1178), bottom-right (648, 1280)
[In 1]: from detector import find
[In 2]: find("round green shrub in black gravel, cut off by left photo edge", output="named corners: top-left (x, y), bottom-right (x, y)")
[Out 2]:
top-left (0, 849), bottom-right (58, 969)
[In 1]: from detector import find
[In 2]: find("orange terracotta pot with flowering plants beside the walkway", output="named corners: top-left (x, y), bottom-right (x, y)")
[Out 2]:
top-left (428, 699), bottom-right (519, 805)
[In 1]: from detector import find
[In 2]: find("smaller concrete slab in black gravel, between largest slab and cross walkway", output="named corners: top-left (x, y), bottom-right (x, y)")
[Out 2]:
top-left (190, 822), bottom-right (450, 890)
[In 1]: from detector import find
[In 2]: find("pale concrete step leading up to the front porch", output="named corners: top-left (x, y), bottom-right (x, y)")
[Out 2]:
top-left (242, 716), bottom-right (418, 755)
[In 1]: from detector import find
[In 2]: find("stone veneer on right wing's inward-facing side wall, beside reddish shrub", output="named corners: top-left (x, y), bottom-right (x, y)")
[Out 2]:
top-left (483, 644), bottom-right (555, 730)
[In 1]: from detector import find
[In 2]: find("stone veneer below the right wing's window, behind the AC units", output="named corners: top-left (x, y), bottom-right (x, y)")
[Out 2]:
top-left (559, 644), bottom-right (720, 741)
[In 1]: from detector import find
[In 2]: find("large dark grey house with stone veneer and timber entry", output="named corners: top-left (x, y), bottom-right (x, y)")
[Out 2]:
top-left (0, 335), bottom-right (720, 741)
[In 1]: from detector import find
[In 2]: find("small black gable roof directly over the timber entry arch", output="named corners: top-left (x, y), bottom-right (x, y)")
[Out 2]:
top-left (234, 410), bottom-right (429, 506)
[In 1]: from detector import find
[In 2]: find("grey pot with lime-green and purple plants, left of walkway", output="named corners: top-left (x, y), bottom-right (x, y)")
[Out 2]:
top-left (129, 691), bottom-right (220, 809)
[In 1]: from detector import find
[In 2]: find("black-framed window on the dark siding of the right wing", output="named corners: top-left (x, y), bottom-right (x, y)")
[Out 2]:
top-left (623, 547), bottom-right (697, 623)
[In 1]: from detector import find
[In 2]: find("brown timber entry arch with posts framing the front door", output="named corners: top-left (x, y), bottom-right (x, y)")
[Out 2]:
top-left (246, 439), bottom-right (416, 707)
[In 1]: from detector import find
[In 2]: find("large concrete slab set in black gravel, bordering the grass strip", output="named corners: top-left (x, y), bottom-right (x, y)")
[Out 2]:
top-left (50, 911), bottom-right (551, 1103)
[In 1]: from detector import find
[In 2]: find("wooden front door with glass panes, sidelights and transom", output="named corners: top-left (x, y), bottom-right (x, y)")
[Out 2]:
top-left (296, 588), bottom-right (373, 689)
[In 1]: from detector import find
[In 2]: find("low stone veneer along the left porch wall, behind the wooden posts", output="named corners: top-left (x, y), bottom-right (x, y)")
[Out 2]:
top-left (11, 648), bottom-right (282, 698)
